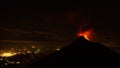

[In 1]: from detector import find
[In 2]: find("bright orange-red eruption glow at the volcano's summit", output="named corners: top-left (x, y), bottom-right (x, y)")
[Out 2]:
top-left (78, 29), bottom-right (93, 41)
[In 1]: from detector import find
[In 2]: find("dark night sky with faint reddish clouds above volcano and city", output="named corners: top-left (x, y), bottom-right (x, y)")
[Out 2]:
top-left (0, 1), bottom-right (120, 49)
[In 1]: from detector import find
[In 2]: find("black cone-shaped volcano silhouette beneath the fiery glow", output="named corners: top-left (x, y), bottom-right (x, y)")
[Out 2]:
top-left (27, 37), bottom-right (120, 68)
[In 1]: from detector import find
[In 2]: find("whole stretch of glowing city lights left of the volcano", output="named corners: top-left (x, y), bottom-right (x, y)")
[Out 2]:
top-left (0, 46), bottom-right (60, 68)
